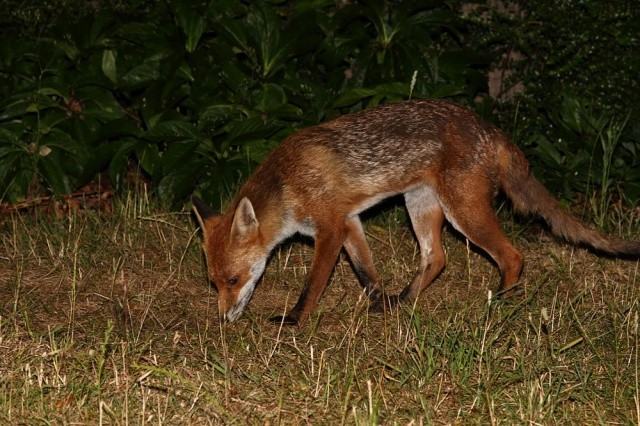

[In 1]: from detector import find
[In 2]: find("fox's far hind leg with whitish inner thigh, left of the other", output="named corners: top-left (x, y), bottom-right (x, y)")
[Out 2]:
top-left (399, 186), bottom-right (446, 302)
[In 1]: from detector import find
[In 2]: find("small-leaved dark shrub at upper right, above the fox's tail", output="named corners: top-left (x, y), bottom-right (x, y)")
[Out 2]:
top-left (470, 0), bottom-right (640, 203)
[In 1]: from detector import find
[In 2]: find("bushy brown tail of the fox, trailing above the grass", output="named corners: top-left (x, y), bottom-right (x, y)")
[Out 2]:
top-left (501, 143), bottom-right (640, 257)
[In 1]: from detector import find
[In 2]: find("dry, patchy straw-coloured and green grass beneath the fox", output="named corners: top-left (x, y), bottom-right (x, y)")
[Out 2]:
top-left (0, 197), bottom-right (640, 425)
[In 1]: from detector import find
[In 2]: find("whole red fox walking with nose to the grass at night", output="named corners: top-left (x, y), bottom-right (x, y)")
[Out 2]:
top-left (192, 100), bottom-right (640, 324)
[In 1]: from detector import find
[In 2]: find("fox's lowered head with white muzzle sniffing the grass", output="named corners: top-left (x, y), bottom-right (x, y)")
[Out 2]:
top-left (191, 196), bottom-right (268, 322)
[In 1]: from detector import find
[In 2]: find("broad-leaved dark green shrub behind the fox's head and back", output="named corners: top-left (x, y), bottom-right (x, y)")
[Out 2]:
top-left (0, 0), bottom-right (484, 206)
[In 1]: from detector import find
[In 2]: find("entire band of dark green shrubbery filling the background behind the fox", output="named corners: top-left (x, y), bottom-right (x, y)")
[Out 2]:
top-left (0, 0), bottom-right (640, 207)
